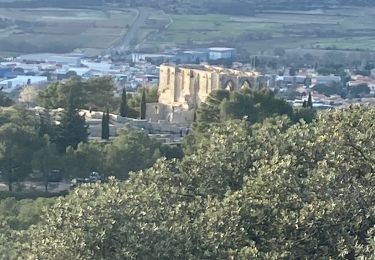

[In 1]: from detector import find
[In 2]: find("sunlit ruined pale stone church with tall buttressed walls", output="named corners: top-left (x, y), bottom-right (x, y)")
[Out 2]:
top-left (147, 64), bottom-right (263, 124)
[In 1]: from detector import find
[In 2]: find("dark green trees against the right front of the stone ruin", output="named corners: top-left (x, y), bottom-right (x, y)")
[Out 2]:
top-left (183, 89), bottom-right (316, 154)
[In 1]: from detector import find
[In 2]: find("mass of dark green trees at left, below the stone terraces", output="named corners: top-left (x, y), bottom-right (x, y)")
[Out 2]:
top-left (0, 104), bottom-right (166, 192)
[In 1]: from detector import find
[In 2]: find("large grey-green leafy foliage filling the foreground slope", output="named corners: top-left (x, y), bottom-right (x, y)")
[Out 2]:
top-left (11, 106), bottom-right (375, 259)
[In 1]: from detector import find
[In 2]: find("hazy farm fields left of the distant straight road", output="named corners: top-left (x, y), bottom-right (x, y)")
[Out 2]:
top-left (0, 8), bottom-right (135, 54)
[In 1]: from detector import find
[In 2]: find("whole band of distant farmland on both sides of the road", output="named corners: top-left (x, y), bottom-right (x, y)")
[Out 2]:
top-left (0, 4), bottom-right (375, 57)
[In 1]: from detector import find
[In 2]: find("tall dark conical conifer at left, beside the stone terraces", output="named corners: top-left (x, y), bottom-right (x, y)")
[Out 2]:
top-left (54, 92), bottom-right (89, 153)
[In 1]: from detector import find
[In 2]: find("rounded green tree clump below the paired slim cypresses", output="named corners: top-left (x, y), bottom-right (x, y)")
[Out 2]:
top-left (63, 129), bottom-right (161, 179)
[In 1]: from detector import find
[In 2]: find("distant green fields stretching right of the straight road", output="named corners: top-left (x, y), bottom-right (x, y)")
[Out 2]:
top-left (142, 7), bottom-right (375, 53)
